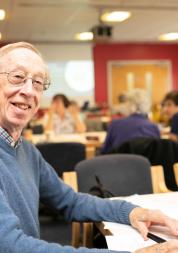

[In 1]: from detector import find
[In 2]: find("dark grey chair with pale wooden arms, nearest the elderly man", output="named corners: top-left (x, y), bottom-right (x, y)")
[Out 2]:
top-left (63, 154), bottom-right (168, 247)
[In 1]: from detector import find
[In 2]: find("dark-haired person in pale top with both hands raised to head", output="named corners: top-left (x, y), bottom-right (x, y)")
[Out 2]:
top-left (45, 94), bottom-right (86, 134)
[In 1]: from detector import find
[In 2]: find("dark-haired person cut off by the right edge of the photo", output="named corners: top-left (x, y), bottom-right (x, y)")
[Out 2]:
top-left (162, 91), bottom-right (178, 141)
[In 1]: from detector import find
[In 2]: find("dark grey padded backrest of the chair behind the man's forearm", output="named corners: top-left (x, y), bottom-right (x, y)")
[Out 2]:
top-left (75, 154), bottom-right (153, 196)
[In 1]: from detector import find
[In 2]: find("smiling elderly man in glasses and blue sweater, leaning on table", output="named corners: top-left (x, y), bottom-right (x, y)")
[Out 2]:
top-left (0, 42), bottom-right (178, 253)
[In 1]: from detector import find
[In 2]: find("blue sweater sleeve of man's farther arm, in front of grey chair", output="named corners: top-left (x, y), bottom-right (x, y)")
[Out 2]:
top-left (40, 157), bottom-right (135, 224)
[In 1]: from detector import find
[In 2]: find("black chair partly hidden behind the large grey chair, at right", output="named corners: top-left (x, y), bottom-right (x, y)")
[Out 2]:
top-left (110, 138), bottom-right (178, 191)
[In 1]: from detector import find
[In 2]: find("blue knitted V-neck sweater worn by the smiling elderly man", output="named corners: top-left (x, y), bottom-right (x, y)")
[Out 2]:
top-left (0, 139), bottom-right (135, 253)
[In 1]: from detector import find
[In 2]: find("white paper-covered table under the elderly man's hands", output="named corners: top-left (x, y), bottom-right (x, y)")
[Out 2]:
top-left (97, 192), bottom-right (178, 252)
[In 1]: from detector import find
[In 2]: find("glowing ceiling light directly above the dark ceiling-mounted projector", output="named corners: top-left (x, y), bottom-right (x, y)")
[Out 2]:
top-left (101, 11), bottom-right (131, 22)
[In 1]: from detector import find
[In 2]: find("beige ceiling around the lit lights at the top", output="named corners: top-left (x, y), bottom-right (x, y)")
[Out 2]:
top-left (0, 0), bottom-right (178, 44)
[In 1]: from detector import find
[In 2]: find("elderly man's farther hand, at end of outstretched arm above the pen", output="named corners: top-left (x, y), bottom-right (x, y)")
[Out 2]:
top-left (129, 207), bottom-right (178, 240)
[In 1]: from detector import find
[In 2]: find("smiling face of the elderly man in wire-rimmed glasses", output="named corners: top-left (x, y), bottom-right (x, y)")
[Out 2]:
top-left (0, 48), bottom-right (46, 133)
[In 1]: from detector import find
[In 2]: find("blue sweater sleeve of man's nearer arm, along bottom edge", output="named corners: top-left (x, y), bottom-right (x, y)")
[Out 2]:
top-left (0, 190), bottom-right (129, 253)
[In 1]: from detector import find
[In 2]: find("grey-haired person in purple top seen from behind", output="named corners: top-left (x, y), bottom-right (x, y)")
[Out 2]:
top-left (101, 89), bottom-right (160, 153)
